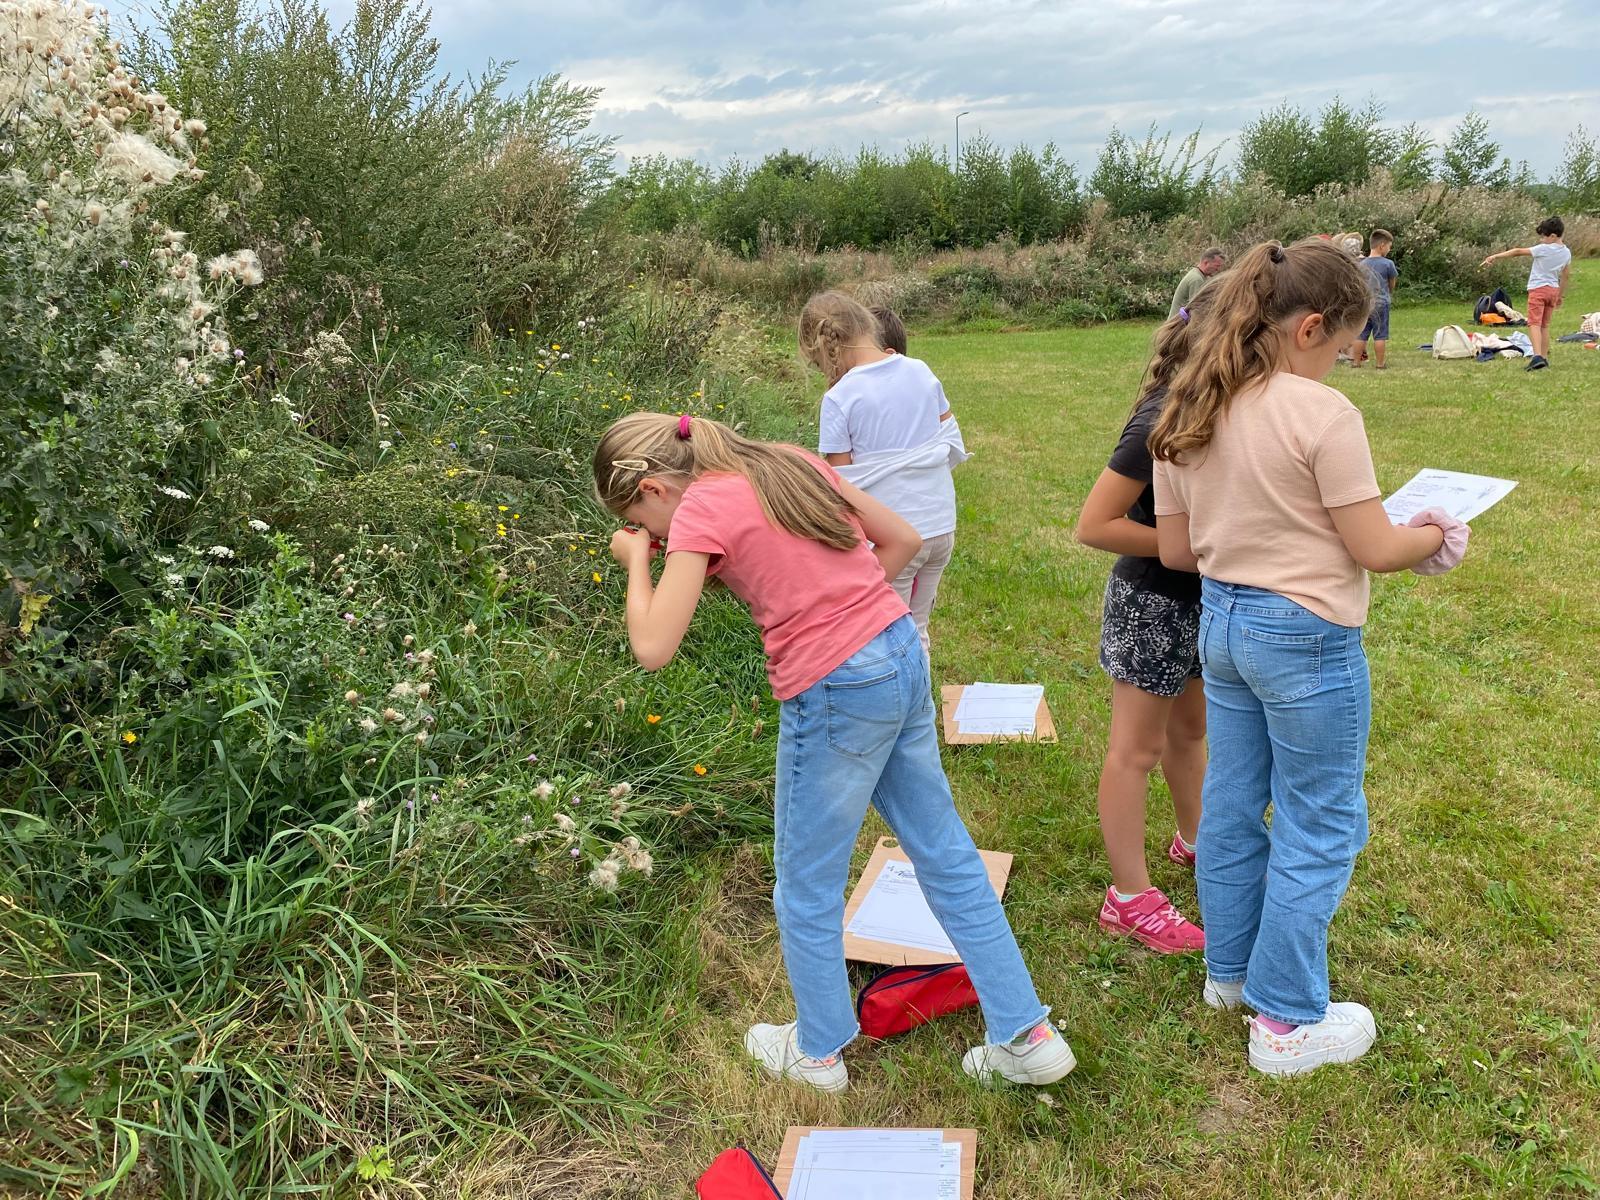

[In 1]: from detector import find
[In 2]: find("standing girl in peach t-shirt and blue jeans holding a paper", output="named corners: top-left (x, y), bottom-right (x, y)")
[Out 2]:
top-left (1149, 240), bottom-right (1467, 1075)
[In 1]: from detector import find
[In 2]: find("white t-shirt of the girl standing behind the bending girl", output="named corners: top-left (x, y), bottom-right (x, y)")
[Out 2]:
top-left (816, 354), bottom-right (950, 454)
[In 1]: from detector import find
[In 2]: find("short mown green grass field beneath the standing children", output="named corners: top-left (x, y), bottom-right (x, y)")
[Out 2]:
top-left (492, 284), bottom-right (1600, 1200)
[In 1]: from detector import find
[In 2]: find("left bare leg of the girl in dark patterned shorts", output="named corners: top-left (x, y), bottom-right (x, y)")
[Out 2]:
top-left (1099, 680), bottom-right (1177, 896)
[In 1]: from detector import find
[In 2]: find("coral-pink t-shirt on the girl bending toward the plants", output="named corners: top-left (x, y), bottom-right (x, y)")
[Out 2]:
top-left (667, 451), bottom-right (910, 699)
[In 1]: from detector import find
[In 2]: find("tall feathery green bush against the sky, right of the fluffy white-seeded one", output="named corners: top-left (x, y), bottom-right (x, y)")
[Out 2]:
top-left (138, 0), bottom-right (610, 350)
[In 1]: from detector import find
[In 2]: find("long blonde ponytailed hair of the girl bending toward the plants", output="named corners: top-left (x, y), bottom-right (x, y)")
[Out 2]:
top-left (594, 413), bottom-right (861, 550)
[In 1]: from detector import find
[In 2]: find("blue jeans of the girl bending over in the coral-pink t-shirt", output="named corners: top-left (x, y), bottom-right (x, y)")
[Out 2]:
top-left (773, 616), bottom-right (1050, 1058)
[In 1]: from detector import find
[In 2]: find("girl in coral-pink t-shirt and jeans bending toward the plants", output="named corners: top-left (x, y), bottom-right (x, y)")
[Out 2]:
top-left (594, 413), bottom-right (1075, 1091)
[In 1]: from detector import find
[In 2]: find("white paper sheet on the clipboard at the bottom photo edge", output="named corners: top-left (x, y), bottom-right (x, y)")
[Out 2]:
top-left (787, 1130), bottom-right (962, 1200)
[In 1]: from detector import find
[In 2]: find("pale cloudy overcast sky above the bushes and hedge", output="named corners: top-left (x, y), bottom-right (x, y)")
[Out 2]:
top-left (109, 0), bottom-right (1600, 178)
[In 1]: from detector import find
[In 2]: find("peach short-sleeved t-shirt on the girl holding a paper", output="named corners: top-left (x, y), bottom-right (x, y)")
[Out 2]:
top-left (1155, 373), bottom-right (1382, 627)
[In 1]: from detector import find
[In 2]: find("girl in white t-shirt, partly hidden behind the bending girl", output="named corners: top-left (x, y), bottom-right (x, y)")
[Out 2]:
top-left (800, 291), bottom-right (966, 650)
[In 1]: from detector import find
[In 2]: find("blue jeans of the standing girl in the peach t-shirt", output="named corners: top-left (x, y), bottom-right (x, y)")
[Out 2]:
top-left (1197, 579), bottom-right (1373, 1026)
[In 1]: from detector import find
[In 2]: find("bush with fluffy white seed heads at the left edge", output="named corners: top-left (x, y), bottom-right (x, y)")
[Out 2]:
top-left (0, 3), bottom-right (272, 707)
